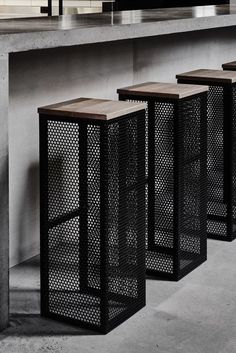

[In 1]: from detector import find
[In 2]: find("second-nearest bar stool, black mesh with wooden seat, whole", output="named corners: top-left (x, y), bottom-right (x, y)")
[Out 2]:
top-left (118, 82), bottom-right (207, 280)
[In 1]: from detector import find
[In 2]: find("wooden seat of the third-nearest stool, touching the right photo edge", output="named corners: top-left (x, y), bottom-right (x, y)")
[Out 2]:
top-left (176, 69), bottom-right (236, 84)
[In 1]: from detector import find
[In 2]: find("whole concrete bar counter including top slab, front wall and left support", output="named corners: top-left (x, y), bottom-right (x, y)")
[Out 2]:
top-left (0, 5), bottom-right (236, 328)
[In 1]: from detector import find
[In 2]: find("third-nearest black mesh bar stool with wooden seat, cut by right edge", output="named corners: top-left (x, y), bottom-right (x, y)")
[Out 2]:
top-left (176, 69), bottom-right (236, 241)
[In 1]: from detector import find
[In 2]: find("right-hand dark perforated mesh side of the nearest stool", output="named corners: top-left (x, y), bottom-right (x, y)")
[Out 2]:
top-left (107, 114), bottom-right (145, 325)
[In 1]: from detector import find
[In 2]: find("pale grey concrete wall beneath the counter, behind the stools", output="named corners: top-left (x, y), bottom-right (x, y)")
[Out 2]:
top-left (9, 28), bottom-right (236, 266)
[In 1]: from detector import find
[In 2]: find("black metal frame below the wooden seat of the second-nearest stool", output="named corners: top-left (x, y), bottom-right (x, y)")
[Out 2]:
top-left (119, 93), bottom-right (207, 281)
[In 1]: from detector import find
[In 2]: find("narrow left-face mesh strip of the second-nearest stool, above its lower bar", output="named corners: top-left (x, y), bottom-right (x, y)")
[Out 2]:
top-left (154, 102), bottom-right (174, 248)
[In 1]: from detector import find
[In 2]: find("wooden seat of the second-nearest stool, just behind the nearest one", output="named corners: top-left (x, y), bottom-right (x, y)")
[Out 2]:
top-left (117, 82), bottom-right (207, 99)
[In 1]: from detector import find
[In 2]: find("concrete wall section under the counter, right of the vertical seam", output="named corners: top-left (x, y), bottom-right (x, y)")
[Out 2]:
top-left (134, 28), bottom-right (236, 82)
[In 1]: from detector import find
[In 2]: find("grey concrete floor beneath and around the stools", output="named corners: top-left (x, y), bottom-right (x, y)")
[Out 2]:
top-left (0, 240), bottom-right (236, 353)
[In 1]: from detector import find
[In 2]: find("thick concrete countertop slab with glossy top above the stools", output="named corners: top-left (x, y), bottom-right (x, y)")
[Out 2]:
top-left (0, 4), bottom-right (236, 53)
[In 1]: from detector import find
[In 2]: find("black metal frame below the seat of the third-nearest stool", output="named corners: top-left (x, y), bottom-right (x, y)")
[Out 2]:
top-left (178, 78), bottom-right (236, 242)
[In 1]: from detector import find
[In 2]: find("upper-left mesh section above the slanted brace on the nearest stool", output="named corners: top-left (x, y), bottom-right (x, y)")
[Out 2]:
top-left (48, 122), bottom-right (79, 221)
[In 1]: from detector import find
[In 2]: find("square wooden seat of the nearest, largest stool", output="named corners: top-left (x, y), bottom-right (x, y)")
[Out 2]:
top-left (38, 98), bottom-right (146, 120)
